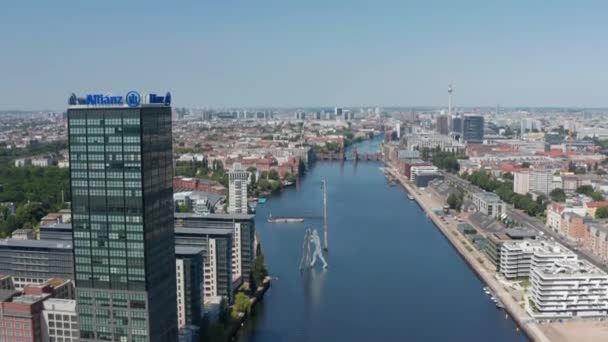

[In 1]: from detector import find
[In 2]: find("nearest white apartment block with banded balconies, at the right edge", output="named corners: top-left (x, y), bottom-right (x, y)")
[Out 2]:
top-left (530, 260), bottom-right (608, 317)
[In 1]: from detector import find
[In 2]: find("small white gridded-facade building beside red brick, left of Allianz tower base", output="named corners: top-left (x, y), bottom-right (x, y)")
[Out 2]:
top-left (41, 298), bottom-right (80, 342)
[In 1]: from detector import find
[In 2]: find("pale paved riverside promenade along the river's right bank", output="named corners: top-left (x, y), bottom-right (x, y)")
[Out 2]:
top-left (386, 164), bottom-right (551, 342)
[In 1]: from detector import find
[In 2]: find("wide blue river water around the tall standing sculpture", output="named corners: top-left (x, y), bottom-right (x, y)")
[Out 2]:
top-left (238, 140), bottom-right (528, 342)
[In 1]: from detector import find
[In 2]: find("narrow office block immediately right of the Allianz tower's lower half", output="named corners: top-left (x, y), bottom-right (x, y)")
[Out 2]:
top-left (175, 246), bottom-right (204, 329)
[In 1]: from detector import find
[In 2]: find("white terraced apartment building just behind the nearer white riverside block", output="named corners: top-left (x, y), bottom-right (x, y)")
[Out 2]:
top-left (500, 240), bottom-right (577, 279)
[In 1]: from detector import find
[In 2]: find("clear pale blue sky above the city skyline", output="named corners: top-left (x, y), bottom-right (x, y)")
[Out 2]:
top-left (0, 0), bottom-right (608, 109)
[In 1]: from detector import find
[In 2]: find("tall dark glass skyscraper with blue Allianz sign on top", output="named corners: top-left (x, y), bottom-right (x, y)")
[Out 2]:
top-left (68, 95), bottom-right (177, 341)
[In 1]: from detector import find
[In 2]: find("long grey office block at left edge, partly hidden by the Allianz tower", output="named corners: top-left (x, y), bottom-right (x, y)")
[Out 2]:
top-left (0, 239), bottom-right (74, 290)
